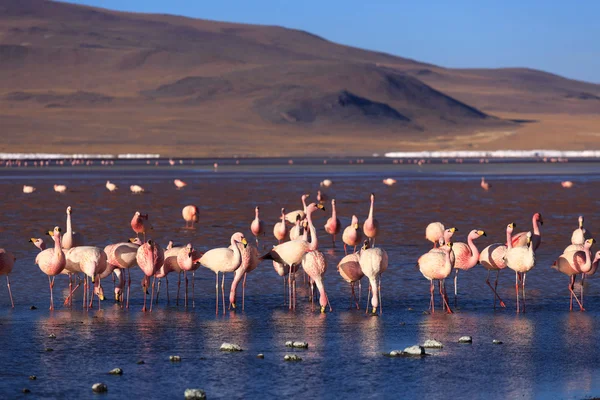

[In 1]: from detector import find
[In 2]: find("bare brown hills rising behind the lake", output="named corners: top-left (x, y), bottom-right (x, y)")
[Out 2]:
top-left (0, 0), bottom-right (600, 156)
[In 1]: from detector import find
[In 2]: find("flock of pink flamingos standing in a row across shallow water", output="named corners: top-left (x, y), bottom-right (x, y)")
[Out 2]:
top-left (0, 178), bottom-right (600, 314)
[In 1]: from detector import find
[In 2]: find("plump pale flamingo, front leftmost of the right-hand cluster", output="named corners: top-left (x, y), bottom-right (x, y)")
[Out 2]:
top-left (417, 242), bottom-right (454, 314)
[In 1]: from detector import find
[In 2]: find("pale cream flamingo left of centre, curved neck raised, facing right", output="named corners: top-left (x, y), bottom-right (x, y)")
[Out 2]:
top-left (199, 232), bottom-right (248, 315)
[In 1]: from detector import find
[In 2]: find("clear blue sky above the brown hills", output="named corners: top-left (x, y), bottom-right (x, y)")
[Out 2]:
top-left (63, 0), bottom-right (600, 83)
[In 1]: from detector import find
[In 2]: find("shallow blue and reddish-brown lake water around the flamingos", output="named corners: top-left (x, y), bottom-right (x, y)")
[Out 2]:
top-left (0, 163), bottom-right (600, 399)
